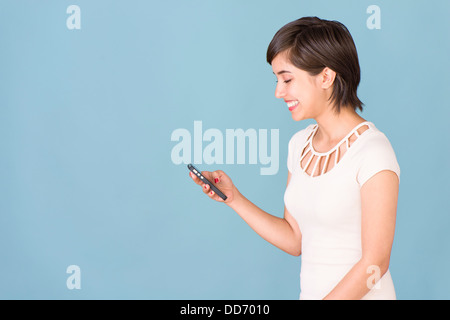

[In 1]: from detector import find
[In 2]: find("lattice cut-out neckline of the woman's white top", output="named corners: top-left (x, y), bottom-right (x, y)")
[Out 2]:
top-left (300, 121), bottom-right (371, 177)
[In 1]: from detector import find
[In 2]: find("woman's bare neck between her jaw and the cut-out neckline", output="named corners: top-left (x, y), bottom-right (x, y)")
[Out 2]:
top-left (315, 107), bottom-right (366, 143)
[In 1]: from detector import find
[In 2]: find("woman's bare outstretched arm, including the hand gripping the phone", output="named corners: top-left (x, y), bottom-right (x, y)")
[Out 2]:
top-left (191, 170), bottom-right (302, 256)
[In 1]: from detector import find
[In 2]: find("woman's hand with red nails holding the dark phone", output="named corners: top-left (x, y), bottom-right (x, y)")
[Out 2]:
top-left (189, 170), bottom-right (237, 204)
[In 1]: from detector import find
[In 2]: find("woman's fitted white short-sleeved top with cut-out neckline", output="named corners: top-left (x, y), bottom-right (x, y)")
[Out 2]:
top-left (284, 121), bottom-right (400, 299)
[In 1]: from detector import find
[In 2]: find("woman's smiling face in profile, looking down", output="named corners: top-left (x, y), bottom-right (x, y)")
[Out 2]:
top-left (272, 52), bottom-right (332, 121)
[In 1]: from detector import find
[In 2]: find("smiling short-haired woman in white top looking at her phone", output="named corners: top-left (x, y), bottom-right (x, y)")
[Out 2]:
top-left (191, 17), bottom-right (400, 299)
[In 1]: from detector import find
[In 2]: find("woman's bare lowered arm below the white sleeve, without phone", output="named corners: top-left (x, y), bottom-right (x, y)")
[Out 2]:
top-left (325, 170), bottom-right (399, 300)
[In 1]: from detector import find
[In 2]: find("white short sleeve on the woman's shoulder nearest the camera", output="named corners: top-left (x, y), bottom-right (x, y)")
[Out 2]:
top-left (357, 132), bottom-right (400, 186)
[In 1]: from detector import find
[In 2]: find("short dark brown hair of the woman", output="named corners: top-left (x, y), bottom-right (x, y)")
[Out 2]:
top-left (267, 17), bottom-right (364, 113)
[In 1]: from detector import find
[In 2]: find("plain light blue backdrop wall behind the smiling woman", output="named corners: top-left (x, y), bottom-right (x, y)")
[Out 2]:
top-left (0, 0), bottom-right (450, 299)
